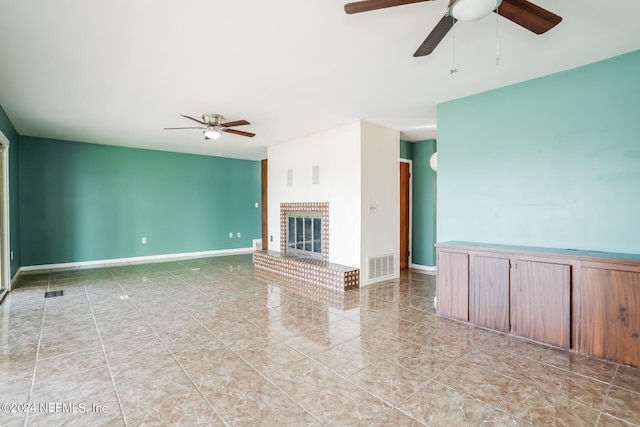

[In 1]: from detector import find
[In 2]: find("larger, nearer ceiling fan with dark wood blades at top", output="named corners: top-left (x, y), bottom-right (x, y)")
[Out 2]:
top-left (344, 0), bottom-right (562, 57)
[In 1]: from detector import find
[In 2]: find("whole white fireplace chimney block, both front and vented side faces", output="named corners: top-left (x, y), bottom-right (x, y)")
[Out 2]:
top-left (268, 122), bottom-right (400, 286)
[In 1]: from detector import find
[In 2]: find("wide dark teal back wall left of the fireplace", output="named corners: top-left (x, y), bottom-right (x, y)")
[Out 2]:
top-left (20, 137), bottom-right (261, 266)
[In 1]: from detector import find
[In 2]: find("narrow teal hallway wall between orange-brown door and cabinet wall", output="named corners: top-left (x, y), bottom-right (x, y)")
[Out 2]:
top-left (400, 139), bottom-right (437, 267)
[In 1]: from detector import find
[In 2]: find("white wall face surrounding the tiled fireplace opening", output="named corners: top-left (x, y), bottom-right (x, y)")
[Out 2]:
top-left (268, 122), bottom-right (364, 268)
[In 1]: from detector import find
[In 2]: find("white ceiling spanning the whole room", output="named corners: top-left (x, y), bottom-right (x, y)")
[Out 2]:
top-left (0, 0), bottom-right (640, 160)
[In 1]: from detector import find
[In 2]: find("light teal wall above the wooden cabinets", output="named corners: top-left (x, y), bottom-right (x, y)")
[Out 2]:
top-left (438, 51), bottom-right (640, 253)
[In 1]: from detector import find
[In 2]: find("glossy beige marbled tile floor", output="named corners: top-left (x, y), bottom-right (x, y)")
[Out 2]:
top-left (0, 255), bottom-right (640, 426)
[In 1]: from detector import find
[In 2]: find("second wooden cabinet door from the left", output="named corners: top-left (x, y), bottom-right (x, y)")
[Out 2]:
top-left (469, 255), bottom-right (509, 332)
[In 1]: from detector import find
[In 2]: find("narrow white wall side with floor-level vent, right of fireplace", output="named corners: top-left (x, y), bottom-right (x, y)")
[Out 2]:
top-left (360, 122), bottom-right (400, 285)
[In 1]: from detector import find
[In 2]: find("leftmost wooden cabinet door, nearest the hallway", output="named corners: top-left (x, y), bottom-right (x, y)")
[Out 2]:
top-left (436, 251), bottom-right (469, 321)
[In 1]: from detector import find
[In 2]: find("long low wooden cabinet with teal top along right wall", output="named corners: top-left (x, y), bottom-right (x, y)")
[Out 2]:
top-left (436, 242), bottom-right (640, 367)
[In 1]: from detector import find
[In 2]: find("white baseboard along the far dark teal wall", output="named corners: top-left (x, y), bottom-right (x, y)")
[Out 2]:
top-left (16, 248), bottom-right (254, 276)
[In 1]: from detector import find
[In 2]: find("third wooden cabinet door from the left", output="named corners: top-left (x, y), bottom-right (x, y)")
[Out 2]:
top-left (511, 261), bottom-right (571, 348)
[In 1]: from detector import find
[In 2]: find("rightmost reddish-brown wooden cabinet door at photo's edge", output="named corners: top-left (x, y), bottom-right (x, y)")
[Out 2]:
top-left (579, 268), bottom-right (640, 366)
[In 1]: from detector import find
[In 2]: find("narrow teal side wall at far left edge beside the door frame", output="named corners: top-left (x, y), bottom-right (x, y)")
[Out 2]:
top-left (0, 106), bottom-right (21, 277)
